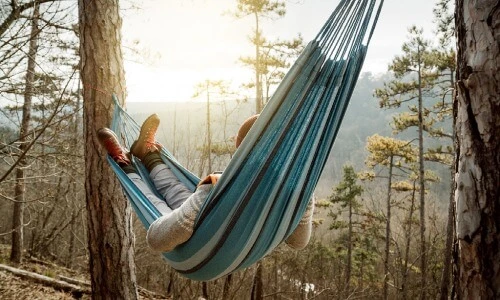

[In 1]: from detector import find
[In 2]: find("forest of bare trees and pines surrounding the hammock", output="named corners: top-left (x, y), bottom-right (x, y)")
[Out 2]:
top-left (0, 0), bottom-right (500, 299)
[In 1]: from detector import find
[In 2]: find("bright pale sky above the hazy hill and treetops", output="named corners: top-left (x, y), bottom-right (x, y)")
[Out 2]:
top-left (122, 0), bottom-right (436, 102)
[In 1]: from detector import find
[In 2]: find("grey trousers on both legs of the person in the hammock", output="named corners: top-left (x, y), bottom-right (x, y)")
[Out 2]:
top-left (127, 164), bottom-right (193, 215)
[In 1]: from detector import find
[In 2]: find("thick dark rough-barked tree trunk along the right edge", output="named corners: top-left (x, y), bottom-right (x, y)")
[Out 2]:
top-left (455, 0), bottom-right (500, 299)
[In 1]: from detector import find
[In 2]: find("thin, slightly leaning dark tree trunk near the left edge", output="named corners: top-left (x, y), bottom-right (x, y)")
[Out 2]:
top-left (10, 4), bottom-right (39, 264)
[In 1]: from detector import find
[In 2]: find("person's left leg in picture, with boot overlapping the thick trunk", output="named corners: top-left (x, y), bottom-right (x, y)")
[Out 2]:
top-left (97, 128), bottom-right (172, 215)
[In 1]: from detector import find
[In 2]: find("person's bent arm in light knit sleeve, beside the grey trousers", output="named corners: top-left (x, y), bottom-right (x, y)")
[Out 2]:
top-left (146, 184), bottom-right (212, 252)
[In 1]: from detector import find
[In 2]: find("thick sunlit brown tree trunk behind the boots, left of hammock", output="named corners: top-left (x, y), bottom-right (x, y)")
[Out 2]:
top-left (78, 0), bottom-right (138, 299)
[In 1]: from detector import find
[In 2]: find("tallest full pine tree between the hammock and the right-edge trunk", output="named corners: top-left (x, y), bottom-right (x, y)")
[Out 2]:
top-left (375, 26), bottom-right (438, 299)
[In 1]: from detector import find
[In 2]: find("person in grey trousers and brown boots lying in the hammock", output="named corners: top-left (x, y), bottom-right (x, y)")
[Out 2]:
top-left (97, 114), bottom-right (314, 252)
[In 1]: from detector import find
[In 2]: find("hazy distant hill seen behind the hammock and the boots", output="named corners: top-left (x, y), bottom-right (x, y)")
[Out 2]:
top-left (127, 73), bottom-right (391, 197)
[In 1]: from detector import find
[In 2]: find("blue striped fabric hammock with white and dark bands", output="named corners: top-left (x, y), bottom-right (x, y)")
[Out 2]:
top-left (108, 0), bottom-right (383, 281)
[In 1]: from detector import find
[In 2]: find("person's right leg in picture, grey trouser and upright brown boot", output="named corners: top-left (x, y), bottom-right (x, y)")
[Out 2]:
top-left (131, 115), bottom-right (192, 209)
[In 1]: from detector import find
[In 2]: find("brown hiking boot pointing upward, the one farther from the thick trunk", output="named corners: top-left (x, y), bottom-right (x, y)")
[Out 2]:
top-left (130, 114), bottom-right (161, 160)
